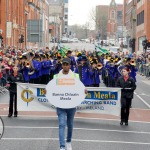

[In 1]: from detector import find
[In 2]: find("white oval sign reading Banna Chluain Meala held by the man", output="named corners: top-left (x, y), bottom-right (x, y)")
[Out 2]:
top-left (46, 76), bottom-right (86, 109)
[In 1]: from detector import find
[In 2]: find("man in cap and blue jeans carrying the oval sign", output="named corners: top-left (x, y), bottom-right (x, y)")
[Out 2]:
top-left (51, 58), bottom-right (87, 150)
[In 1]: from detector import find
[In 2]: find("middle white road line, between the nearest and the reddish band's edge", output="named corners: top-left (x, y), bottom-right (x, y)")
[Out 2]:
top-left (5, 126), bottom-right (150, 134)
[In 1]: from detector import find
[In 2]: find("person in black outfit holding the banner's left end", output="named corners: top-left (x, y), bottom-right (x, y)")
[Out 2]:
top-left (7, 66), bottom-right (23, 117)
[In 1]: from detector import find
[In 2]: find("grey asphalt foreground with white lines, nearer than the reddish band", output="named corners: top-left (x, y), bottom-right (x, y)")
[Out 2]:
top-left (0, 117), bottom-right (150, 150)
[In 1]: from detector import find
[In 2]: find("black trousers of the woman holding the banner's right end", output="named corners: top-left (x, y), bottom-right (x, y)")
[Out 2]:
top-left (121, 99), bottom-right (132, 122)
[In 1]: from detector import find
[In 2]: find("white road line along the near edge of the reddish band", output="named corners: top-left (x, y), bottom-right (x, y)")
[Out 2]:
top-left (1, 115), bottom-right (150, 124)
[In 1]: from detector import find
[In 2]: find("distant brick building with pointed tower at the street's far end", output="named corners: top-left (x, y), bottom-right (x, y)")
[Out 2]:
top-left (96, 0), bottom-right (123, 39)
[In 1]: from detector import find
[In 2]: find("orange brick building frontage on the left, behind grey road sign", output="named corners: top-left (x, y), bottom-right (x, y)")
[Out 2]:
top-left (0, 0), bottom-right (49, 48)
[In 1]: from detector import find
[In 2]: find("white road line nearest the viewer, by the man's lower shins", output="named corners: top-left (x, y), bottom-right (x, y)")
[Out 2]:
top-left (1, 138), bottom-right (150, 145)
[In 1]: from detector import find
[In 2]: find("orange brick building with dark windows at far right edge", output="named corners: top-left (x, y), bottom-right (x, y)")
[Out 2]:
top-left (136, 0), bottom-right (150, 53)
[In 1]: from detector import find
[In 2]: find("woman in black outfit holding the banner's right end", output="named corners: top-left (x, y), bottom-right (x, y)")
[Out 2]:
top-left (117, 67), bottom-right (136, 125)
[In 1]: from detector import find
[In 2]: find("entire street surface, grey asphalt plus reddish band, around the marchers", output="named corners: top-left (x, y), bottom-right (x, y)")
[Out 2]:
top-left (0, 75), bottom-right (150, 150)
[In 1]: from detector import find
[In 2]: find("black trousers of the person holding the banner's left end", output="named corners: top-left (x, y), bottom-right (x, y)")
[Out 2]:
top-left (9, 92), bottom-right (18, 115)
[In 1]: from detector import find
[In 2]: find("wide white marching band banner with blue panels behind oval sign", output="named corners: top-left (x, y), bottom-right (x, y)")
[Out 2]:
top-left (17, 83), bottom-right (121, 116)
